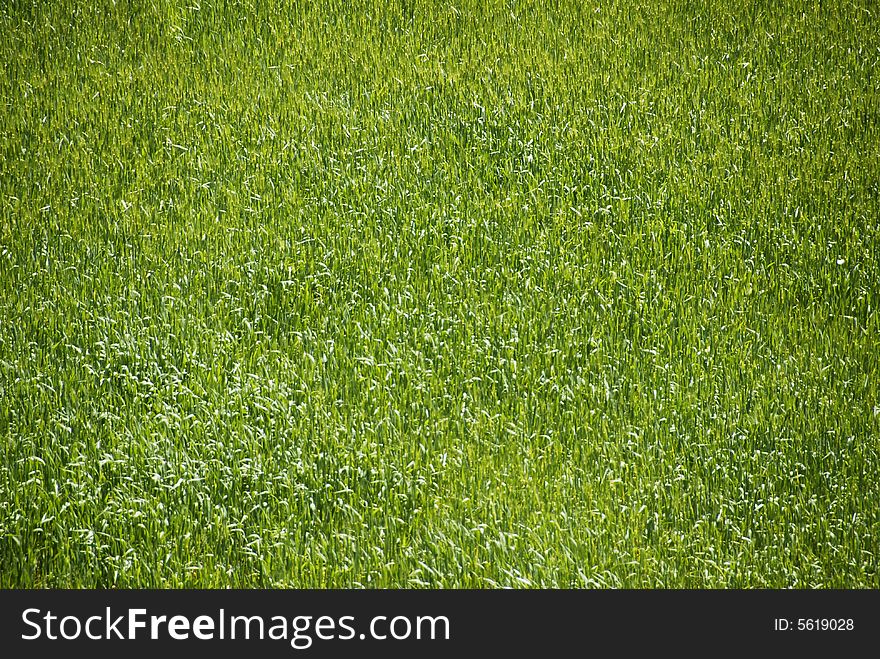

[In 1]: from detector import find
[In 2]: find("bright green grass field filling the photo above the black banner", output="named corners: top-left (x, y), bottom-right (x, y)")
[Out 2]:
top-left (0, 0), bottom-right (880, 588)
